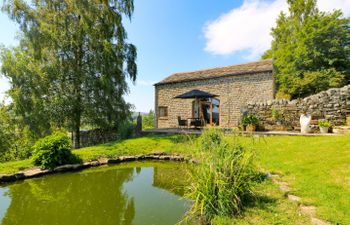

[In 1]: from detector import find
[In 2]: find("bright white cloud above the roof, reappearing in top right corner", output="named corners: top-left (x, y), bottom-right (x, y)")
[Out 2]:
top-left (204, 0), bottom-right (350, 59)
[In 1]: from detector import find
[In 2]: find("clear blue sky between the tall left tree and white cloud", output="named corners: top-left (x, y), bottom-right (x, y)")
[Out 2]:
top-left (126, 0), bottom-right (245, 111)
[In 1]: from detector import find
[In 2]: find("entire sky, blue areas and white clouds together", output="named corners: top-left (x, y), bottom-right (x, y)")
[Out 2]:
top-left (0, 0), bottom-right (350, 112)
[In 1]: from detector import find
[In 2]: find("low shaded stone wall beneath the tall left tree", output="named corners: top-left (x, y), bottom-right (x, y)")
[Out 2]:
top-left (72, 129), bottom-right (119, 148)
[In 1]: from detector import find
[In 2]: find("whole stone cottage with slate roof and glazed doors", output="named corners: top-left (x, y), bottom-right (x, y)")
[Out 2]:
top-left (154, 60), bottom-right (274, 128)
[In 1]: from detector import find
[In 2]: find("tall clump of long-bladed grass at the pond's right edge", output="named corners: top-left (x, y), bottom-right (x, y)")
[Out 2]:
top-left (187, 129), bottom-right (256, 224)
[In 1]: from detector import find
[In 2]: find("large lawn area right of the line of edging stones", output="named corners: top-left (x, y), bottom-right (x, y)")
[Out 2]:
top-left (246, 135), bottom-right (350, 224)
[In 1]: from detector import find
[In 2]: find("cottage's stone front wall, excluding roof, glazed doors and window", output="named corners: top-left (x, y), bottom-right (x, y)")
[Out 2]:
top-left (155, 72), bottom-right (274, 128)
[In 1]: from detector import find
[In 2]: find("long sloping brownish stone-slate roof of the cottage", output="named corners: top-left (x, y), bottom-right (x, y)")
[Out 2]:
top-left (155, 59), bottom-right (273, 86)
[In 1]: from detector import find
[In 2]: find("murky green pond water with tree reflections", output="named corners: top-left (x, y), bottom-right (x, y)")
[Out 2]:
top-left (0, 162), bottom-right (190, 225)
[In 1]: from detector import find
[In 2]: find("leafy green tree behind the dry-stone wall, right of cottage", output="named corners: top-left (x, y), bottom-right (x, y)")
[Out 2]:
top-left (262, 0), bottom-right (350, 98)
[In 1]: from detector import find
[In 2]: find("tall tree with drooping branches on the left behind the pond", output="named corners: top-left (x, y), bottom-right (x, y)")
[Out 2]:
top-left (2, 0), bottom-right (137, 148)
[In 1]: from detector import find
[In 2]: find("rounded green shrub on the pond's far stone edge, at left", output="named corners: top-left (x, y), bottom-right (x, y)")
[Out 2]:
top-left (32, 132), bottom-right (81, 169)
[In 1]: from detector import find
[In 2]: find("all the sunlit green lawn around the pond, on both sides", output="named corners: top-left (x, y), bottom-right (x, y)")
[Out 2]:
top-left (0, 135), bottom-right (350, 224)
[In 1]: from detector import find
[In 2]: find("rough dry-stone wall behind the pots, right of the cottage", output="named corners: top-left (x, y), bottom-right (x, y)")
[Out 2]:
top-left (247, 85), bottom-right (350, 130)
